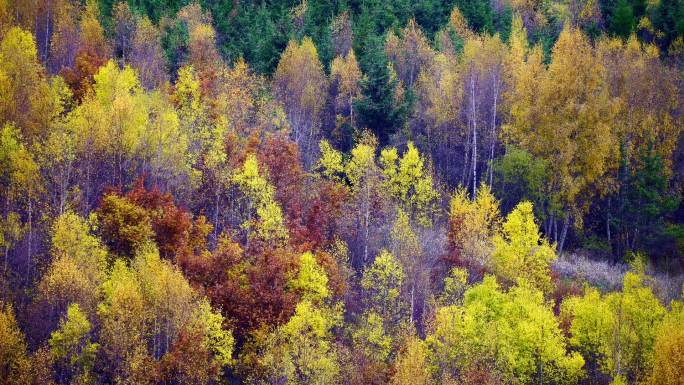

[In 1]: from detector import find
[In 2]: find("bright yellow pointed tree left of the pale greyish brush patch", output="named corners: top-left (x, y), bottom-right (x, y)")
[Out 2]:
top-left (492, 202), bottom-right (556, 293)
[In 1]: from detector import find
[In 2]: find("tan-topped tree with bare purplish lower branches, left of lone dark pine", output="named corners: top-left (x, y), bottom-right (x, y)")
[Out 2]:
top-left (273, 37), bottom-right (327, 167)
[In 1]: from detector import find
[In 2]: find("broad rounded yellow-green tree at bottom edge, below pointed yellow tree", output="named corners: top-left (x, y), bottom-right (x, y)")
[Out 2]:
top-left (426, 276), bottom-right (584, 384)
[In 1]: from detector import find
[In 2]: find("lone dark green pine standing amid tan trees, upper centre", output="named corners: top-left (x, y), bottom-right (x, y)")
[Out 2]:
top-left (355, 36), bottom-right (407, 145)
